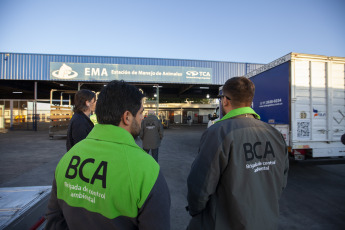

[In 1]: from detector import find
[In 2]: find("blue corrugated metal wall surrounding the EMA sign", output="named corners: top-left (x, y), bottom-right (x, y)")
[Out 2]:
top-left (0, 53), bottom-right (263, 85)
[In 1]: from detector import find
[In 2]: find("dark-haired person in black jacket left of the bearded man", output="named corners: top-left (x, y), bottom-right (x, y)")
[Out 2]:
top-left (66, 89), bottom-right (97, 151)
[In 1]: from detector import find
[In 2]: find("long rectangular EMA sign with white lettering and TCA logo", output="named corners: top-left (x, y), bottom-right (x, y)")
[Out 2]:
top-left (50, 62), bottom-right (212, 84)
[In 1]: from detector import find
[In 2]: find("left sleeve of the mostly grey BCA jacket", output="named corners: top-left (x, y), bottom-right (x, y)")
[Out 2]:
top-left (187, 127), bottom-right (229, 216)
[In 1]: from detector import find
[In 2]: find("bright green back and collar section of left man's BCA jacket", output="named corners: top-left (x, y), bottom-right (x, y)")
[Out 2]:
top-left (55, 124), bottom-right (160, 219)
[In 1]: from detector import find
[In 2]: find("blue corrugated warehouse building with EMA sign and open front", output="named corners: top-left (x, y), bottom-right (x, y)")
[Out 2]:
top-left (0, 52), bottom-right (263, 130)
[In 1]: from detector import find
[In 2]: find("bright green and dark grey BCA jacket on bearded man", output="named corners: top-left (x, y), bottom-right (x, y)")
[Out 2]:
top-left (46, 124), bottom-right (170, 230)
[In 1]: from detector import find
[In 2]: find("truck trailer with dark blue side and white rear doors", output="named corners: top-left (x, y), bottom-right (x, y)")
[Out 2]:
top-left (246, 53), bottom-right (345, 160)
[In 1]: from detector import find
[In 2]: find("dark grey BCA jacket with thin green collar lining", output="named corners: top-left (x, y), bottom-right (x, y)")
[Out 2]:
top-left (187, 107), bottom-right (289, 230)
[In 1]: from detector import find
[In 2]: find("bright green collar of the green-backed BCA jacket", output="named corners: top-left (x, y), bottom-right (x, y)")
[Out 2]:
top-left (86, 124), bottom-right (138, 146)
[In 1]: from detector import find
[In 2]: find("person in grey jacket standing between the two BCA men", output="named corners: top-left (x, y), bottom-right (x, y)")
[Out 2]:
top-left (140, 111), bottom-right (163, 162)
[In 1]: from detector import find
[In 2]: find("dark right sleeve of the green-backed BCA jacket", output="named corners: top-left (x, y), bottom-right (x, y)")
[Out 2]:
top-left (138, 172), bottom-right (171, 230)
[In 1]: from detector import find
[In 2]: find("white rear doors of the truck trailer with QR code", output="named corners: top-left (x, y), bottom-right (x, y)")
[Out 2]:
top-left (291, 58), bottom-right (345, 157)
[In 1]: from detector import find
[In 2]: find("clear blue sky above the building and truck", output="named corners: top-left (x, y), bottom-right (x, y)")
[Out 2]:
top-left (0, 0), bottom-right (345, 64)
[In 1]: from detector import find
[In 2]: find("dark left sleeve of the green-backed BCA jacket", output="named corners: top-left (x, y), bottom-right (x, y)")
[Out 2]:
top-left (45, 179), bottom-right (68, 229)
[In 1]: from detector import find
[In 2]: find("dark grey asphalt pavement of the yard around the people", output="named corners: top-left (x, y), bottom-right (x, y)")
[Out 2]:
top-left (0, 125), bottom-right (345, 230)
